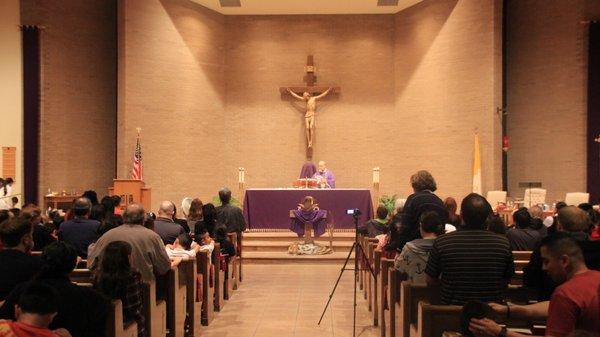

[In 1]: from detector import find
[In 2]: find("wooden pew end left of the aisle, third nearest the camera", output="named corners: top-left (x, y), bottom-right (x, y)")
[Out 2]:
top-left (166, 261), bottom-right (189, 337)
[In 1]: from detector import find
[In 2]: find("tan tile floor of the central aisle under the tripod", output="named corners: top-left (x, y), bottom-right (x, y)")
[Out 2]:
top-left (200, 263), bottom-right (379, 337)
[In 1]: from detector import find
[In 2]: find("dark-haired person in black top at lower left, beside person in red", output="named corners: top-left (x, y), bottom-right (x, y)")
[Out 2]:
top-left (0, 241), bottom-right (111, 337)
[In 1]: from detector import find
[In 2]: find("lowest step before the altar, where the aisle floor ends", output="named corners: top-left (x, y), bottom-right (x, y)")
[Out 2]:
top-left (242, 249), bottom-right (354, 262)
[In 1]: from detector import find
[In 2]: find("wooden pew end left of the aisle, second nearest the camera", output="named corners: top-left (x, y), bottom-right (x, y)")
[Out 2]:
top-left (142, 281), bottom-right (167, 337)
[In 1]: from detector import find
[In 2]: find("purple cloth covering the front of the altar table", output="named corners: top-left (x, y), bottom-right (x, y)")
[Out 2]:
top-left (244, 189), bottom-right (373, 229)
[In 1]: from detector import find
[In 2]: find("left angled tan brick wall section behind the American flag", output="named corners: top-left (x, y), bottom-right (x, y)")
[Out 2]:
top-left (118, 0), bottom-right (227, 205)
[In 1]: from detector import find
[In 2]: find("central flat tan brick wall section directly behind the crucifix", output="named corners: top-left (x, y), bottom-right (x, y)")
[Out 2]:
top-left (224, 15), bottom-right (404, 194)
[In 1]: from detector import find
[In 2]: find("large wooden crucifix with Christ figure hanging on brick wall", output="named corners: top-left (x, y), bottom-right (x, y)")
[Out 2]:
top-left (279, 55), bottom-right (340, 158)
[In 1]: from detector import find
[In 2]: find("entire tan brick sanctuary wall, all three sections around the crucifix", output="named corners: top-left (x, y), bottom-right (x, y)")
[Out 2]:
top-left (118, 0), bottom-right (500, 204)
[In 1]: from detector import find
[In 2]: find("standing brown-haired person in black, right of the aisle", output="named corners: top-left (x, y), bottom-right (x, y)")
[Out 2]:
top-left (400, 170), bottom-right (448, 244)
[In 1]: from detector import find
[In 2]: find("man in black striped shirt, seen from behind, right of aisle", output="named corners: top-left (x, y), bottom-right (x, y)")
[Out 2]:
top-left (425, 193), bottom-right (515, 305)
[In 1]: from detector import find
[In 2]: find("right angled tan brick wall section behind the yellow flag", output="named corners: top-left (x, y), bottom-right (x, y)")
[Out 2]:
top-left (392, 0), bottom-right (502, 202)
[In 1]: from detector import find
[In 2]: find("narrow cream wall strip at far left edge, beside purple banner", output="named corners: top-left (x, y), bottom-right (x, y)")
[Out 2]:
top-left (0, 0), bottom-right (23, 205)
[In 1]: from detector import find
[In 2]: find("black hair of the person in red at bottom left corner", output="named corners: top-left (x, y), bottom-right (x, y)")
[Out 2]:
top-left (17, 282), bottom-right (59, 315)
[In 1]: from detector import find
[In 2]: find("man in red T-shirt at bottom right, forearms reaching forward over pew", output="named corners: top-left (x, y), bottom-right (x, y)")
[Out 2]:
top-left (470, 232), bottom-right (600, 337)
